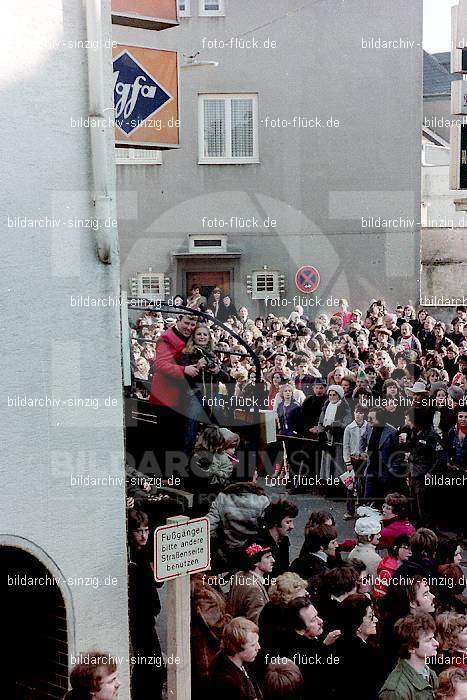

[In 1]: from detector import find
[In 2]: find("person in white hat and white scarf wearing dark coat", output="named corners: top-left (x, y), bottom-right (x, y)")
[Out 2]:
top-left (318, 384), bottom-right (352, 482)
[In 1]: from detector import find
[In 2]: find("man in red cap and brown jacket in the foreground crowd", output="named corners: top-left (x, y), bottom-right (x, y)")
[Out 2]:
top-left (227, 537), bottom-right (274, 624)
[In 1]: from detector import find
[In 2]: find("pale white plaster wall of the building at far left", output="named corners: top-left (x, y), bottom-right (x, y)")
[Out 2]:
top-left (0, 0), bottom-right (128, 697)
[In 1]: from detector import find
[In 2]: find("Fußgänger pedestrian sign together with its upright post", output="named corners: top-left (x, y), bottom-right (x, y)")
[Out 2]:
top-left (154, 515), bottom-right (210, 700)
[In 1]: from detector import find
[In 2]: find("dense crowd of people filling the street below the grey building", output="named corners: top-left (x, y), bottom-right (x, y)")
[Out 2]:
top-left (64, 285), bottom-right (467, 700)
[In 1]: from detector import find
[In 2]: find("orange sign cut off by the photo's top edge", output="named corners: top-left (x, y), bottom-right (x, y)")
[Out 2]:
top-left (112, 0), bottom-right (178, 29)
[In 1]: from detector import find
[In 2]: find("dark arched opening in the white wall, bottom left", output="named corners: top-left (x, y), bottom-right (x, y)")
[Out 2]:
top-left (0, 545), bottom-right (68, 700)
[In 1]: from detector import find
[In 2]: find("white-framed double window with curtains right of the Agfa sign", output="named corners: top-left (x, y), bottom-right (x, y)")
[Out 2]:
top-left (199, 94), bottom-right (259, 165)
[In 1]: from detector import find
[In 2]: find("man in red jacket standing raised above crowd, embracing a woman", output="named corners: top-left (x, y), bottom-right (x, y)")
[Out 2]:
top-left (149, 314), bottom-right (206, 466)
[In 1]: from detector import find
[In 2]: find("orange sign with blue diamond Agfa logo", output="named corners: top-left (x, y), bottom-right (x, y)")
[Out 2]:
top-left (113, 45), bottom-right (180, 149)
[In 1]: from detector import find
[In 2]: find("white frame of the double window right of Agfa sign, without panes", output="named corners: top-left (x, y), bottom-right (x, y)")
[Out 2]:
top-left (198, 92), bottom-right (260, 165)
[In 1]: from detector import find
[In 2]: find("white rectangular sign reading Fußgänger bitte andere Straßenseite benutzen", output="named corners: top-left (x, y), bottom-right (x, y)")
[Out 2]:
top-left (154, 518), bottom-right (210, 581)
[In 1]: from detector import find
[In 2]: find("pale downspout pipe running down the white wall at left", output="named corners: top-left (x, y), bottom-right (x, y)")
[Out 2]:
top-left (85, 0), bottom-right (113, 265)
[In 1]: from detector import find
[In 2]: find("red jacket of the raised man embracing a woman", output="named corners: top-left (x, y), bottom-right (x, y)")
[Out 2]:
top-left (149, 328), bottom-right (188, 408)
